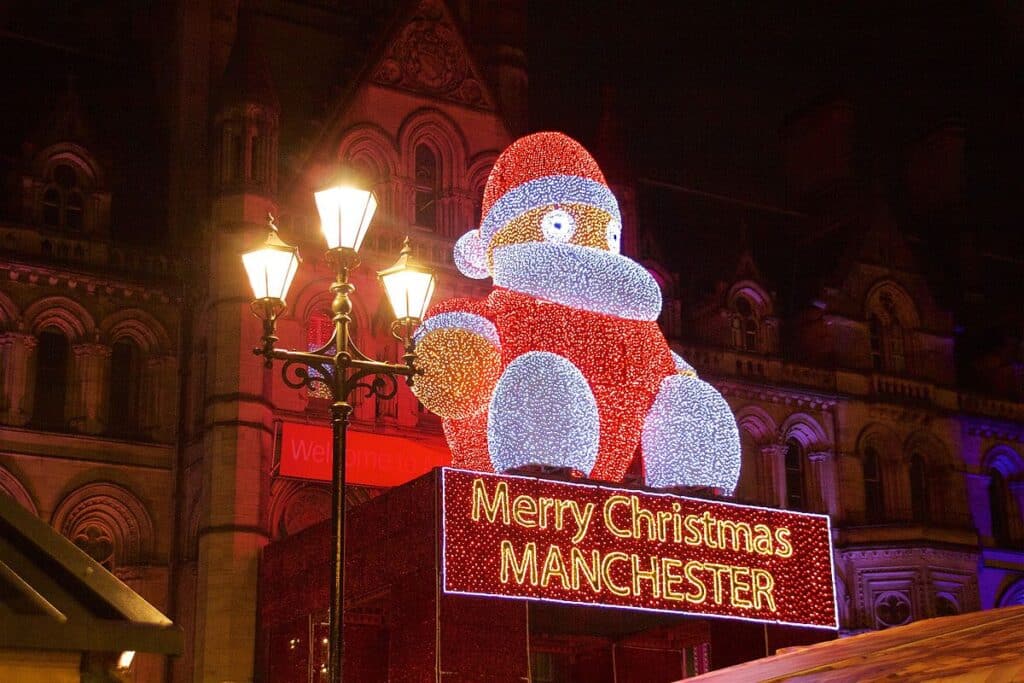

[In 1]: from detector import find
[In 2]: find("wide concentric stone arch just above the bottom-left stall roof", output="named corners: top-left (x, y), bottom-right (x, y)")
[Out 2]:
top-left (50, 482), bottom-right (154, 567)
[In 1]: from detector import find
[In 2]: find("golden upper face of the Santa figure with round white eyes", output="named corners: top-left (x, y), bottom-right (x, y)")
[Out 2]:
top-left (487, 203), bottom-right (622, 269)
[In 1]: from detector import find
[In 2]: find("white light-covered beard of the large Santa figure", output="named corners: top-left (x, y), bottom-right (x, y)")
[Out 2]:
top-left (493, 242), bottom-right (662, 321)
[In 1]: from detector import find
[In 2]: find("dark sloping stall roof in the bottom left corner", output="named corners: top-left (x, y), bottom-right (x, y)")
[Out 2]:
top-left (0, 495), bottom-right (182, 654)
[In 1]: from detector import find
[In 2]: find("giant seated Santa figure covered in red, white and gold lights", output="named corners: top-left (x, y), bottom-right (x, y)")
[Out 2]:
top-left (415, 132), bottom-right (739, 492)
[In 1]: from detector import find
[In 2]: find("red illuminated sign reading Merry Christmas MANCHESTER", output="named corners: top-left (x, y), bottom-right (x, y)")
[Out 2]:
top-left (441, 468), bottom-right (838, 629)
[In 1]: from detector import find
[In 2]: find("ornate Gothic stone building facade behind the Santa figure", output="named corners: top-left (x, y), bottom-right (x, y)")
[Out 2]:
top-left (0, 0), bottom-right (1024, 681)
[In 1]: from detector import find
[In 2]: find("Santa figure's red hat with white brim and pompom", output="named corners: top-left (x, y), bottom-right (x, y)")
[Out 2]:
top-left (455, 132), bottom-right (622, 278)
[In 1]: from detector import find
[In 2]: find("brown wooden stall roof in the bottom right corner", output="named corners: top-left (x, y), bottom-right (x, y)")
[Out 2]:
top-left (691, 606), bottom-right (1024, 682)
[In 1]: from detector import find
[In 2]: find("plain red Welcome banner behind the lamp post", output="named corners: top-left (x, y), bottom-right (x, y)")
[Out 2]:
top-left (278, 422), bottom-right (452, 486)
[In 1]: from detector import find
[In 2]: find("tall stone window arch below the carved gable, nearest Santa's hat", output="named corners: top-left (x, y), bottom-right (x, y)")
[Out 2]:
top-left (398, 108), bottom-right (468, 185)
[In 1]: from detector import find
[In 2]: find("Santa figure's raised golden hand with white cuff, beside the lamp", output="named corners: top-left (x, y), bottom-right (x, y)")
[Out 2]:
top-left (413, 301), bottom-right (502, 420)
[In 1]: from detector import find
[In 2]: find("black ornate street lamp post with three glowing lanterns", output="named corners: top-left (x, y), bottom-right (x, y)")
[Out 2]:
top-left (242, 187), bottom-right (435, 683)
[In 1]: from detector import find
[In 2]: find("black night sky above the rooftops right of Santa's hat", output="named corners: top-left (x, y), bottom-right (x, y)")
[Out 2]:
top-left (528, 1), bottom-right (1024, 226)
